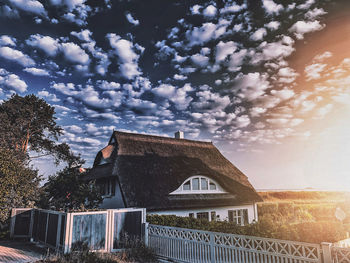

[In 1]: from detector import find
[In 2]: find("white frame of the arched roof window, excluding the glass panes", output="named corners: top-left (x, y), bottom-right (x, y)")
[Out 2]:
top-left (170, 175), bottom-right (227, 195)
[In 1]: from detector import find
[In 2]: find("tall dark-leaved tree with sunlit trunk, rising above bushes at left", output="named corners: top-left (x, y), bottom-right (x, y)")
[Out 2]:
top-left (0, 94), bottom-right (77, 163)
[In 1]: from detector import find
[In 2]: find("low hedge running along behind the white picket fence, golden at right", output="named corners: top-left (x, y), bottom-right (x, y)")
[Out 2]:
top-left (147, 212), bottom-right (347, 243)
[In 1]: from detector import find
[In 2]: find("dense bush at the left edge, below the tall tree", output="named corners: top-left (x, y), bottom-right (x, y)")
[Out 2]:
top-left (0, 147), bottom-right (40, 223)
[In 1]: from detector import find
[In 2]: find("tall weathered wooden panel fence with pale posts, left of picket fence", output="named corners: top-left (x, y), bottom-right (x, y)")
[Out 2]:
top-left (10, 208), bottom-right (146, 252)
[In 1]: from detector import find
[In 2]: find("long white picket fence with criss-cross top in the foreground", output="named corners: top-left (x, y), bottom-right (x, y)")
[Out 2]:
top-left (148, 225), bottom-right (350, 263)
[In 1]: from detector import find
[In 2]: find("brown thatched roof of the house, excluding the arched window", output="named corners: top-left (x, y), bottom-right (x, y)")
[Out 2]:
top-left (88, 131), bottom-right (261, 210)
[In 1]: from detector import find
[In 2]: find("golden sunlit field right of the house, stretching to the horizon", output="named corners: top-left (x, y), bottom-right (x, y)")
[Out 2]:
top-left (254, 191), bottom-right (350, 243)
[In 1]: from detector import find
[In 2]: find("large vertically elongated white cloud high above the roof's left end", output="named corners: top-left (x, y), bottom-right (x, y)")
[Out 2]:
top-left (107, 33), bottom-right (143, 79)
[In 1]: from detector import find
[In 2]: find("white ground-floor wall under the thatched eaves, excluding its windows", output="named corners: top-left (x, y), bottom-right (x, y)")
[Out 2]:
top-left (147, 203), bottom-right (258, 224)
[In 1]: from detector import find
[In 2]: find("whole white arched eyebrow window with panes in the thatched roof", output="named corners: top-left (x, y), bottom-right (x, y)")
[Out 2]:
top-left (170, 176), bottom-right (227, 194)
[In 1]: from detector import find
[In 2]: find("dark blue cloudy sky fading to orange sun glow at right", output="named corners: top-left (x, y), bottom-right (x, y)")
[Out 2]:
top-left (0, 0), bottom-right (350, 190)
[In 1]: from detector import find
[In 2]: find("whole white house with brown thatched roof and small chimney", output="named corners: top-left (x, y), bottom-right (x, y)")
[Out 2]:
top-left (86, 131), bottom-right (262, 225)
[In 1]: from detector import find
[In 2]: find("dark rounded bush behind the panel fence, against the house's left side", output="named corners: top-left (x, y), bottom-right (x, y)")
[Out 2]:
top-left (40, 166), bottom-right (102, 210)
